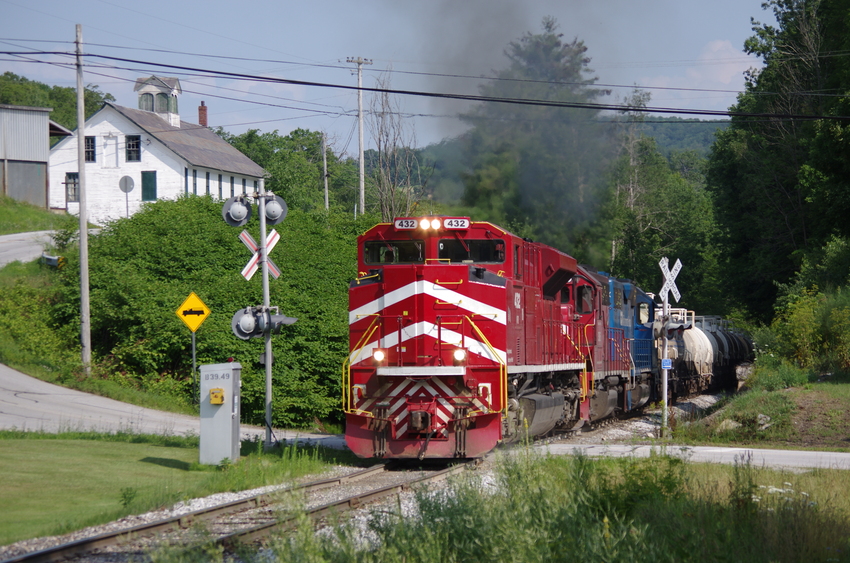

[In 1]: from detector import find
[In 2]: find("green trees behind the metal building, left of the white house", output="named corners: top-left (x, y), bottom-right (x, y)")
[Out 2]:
top-left (0, 72), bottom-right (115, 129)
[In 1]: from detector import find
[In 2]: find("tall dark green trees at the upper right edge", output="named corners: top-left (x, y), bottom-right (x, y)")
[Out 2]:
top-left (708, 0), bottom-right (850, 320)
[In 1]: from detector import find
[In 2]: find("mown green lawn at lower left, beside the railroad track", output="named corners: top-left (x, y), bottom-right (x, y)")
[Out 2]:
top-left (0, 432), bottom-right (362, 545)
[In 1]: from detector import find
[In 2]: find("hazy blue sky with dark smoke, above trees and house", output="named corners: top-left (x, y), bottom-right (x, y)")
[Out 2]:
top-left (0, 0), bottom-right (775, 155)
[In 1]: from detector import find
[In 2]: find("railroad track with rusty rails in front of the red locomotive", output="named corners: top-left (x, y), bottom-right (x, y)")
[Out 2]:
top-left (0, 463), bottom-right (466, 563)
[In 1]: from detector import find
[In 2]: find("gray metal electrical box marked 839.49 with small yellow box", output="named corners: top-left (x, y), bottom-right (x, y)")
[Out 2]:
top-left (200, 362), bottom-right (242, 465)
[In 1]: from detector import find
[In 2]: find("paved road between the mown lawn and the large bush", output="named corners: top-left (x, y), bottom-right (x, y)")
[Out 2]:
top-left (0, 364), bottom-right (343, 448)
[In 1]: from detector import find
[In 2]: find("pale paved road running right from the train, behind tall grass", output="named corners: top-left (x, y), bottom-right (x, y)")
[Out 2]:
top-left (539, 444), bottom-right (850, 470)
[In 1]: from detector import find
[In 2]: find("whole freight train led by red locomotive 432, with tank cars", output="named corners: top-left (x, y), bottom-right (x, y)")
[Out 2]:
top-left (342, 217), bottom-right (749, 459)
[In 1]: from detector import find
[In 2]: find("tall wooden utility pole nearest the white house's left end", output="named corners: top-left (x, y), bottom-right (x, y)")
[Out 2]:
top-left (77, 24), bottom-right (91, 376)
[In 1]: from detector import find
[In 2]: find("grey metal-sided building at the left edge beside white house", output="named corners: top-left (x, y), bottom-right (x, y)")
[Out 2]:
top-left (0, 104), bottom-right (73, 209)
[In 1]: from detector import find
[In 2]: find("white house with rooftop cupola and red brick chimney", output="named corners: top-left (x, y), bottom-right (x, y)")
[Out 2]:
top-left (48, 76), bottom-right (264, 224)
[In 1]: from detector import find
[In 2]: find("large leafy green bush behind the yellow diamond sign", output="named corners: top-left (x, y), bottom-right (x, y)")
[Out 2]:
top-left (6, 196), bottom-right (375, 426)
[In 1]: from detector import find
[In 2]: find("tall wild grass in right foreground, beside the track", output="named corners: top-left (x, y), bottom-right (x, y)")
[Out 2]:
top-left (258, 454), bottom-right (850, 563)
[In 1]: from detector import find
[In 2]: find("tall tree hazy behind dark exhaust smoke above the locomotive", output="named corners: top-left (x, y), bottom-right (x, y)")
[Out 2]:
top-left (462, 17), bottom-right (613, 262)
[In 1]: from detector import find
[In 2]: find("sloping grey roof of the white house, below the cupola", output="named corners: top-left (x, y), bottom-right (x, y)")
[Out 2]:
top-left (104, 102), bottom-right (265, 178)
